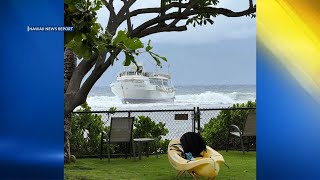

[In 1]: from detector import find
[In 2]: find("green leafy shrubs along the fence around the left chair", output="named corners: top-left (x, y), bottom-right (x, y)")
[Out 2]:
top-left (70, 103), bottom-right (169, 156)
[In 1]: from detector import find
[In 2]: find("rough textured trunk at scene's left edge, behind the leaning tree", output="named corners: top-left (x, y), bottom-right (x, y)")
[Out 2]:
top-left (64, 48), bottom-right (76, 163)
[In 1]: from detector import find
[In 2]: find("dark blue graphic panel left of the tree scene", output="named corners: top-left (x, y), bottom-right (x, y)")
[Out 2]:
top-left (0, 0), bottom-right (64, 179)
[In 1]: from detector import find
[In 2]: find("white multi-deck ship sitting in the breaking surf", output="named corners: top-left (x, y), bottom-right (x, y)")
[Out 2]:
top-left (110, 63), bottom-right (175, 104)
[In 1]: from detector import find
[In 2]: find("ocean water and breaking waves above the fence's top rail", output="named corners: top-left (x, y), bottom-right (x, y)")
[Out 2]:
top-left (87, 85), bottom-right (256, 111)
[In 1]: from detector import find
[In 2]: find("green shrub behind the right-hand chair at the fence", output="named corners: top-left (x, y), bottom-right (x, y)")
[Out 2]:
top-left (202, 101), bottom-right (256, 149)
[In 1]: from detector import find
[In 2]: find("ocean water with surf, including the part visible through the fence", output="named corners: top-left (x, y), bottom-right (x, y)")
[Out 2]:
top-left (87, 85), bottom-right (256, 139)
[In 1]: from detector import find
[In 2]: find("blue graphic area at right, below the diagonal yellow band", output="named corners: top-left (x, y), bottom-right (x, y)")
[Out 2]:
top-left (257, 46), bottom-right (320, 179)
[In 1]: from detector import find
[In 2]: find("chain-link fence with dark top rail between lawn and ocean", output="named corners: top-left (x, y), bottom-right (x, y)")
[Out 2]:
top-left (73, 107), bottom-right (255, 158)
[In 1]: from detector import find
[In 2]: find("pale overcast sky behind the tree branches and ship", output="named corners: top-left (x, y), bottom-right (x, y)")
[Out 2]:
top-left (92, 0), bottom-right (256, 86)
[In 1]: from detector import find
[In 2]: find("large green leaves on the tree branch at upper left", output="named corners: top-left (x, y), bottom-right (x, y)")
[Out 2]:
top-left (65, 0), bottom-right (167, 66)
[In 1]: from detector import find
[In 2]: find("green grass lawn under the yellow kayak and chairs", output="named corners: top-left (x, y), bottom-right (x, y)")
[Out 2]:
top-left (64, 151), bottom-right (256, 180)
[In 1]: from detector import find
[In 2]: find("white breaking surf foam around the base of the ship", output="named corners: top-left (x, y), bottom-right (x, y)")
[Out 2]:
top-left (87, 91), bottom-right (256, 110)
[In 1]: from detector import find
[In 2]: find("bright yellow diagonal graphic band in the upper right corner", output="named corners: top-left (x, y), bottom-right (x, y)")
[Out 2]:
top-left (257, 0), bottom-right (320, 101)
